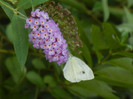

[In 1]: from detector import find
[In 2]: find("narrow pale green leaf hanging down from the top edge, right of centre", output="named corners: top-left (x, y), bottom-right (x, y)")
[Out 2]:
top-left (102, 0), bottom-right (110, 21)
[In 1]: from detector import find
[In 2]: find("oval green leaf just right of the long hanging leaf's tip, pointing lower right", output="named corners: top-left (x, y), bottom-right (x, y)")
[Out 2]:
top-left (26, 71), bottom-right (45, 87)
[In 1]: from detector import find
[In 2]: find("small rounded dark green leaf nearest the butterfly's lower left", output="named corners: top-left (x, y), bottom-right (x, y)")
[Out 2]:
top-left (43, 75), bottom-right (57, 87)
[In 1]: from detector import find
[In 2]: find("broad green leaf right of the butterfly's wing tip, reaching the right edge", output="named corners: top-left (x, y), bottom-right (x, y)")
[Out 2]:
top-left (95, 67), bottom-right (133, 88)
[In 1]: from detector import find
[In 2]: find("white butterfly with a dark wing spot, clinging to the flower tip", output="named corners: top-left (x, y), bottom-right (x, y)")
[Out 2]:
top-left (63, 56), bottom-right (94, 82)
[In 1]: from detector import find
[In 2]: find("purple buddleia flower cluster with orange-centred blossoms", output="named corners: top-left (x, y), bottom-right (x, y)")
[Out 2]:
top-left (25, 9), bottom-right (68, 65)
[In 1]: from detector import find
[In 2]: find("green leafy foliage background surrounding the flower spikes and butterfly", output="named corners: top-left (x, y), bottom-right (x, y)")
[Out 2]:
top-left (0, 0), bottom-right (133, 99)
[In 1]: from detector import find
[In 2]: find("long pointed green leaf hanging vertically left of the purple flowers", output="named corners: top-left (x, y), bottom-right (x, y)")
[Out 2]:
top-left (12, 15), bottom-right (28, 66)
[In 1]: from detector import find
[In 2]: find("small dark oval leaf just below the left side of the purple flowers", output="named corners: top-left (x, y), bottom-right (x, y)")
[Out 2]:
top-left (32, 58), bottom-right (45, 69)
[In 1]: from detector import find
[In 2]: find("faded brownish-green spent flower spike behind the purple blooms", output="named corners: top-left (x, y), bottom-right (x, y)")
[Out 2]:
top-left (37, 1), bottom-right (83, 54)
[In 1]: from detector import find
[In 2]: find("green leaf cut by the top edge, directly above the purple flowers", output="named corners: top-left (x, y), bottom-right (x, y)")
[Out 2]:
top-left (17, 0), bottom-right (48, 9)
